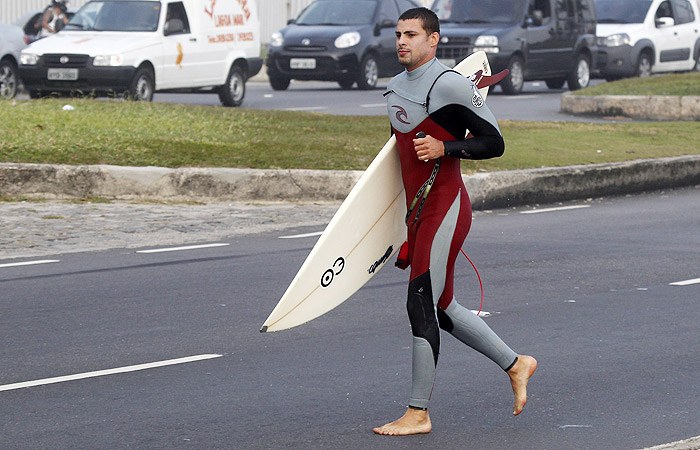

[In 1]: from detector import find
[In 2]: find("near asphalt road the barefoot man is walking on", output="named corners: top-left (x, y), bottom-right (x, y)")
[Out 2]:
top-left (0, 188), bottom-right (700, 450)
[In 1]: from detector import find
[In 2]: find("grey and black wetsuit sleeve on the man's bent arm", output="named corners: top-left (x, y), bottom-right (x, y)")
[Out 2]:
top-left (430, 74), bottom-right (505, 159)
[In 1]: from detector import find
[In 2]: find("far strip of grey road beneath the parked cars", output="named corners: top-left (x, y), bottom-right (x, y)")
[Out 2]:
top-left (154, 79), bottom-right (611, 122)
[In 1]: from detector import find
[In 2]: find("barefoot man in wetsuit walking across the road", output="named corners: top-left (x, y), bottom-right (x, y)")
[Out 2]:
top-left (374, 8), bottom-right (537, 435)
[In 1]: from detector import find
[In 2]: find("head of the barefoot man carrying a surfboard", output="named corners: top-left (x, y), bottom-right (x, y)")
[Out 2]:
top-left (396, 8), bottom-right (440, 71)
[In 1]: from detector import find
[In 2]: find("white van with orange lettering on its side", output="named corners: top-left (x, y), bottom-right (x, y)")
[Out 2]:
top-left (19, 0), bottom-right (262, 106)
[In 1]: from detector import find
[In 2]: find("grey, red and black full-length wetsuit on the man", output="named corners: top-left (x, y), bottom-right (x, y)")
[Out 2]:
top-left (384, 59), bottom-right (517, 409)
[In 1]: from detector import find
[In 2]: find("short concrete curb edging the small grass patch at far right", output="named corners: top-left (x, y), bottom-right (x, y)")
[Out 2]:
top-left (561, 92), bottom-right (700, 121)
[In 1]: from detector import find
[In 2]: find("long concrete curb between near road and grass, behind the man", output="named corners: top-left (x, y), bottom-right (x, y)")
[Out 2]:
top-left (0, 156), bottom-right (700, 209)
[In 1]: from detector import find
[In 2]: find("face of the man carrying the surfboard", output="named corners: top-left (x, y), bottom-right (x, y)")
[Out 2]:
top-left (396, 19), bottom-right (440, 71)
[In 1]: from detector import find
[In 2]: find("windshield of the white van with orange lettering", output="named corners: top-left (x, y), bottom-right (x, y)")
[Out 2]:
top-left (66, 1), bottom-right (160, 31)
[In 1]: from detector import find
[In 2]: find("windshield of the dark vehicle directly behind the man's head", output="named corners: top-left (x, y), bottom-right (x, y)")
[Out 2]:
top-left (431, 0), bottom-right (525, 24)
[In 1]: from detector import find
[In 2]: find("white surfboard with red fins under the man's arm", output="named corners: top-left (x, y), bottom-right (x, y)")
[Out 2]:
top-left (260, 52), bottom-right (498, 332)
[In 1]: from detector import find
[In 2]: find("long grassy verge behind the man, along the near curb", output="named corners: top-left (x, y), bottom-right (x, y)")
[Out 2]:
top-left (0, 99), bottom-right (700, 172)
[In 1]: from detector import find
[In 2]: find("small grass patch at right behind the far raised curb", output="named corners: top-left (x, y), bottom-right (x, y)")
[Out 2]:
top-left (573, 72), bottom-right (700, 96)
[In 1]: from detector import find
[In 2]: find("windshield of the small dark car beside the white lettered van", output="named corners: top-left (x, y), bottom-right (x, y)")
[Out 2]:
top-left (296, 0), bottom-right (377, 25)
